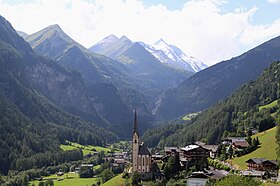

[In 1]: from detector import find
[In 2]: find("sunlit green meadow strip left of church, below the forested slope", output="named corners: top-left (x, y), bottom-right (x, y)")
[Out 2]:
top-left (60, 142), bottom-right (111, 155)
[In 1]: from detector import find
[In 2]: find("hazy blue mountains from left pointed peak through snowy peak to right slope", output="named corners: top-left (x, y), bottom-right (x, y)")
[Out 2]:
top-left (7, 15), bottom-right (280, 135)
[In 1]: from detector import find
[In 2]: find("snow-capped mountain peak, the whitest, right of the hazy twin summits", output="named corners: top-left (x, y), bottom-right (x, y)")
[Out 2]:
top-left (139, 39), bottom-right (207, 72)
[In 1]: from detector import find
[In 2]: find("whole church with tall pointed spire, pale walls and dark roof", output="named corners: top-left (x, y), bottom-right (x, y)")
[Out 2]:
top-left (132, 109), bottom-right (152, 174)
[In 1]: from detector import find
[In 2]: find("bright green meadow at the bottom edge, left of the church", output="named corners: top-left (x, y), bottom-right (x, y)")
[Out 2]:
top-left (29, 173), bottom-right (99, 186)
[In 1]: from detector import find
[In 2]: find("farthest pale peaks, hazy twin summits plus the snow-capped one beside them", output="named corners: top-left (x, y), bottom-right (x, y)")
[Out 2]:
top-left (89, 35), bottom-right (207, 72)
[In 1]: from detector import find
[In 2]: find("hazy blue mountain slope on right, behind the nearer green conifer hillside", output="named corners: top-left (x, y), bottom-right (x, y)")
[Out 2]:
top-left (154, 34), bottom-right (280, 119)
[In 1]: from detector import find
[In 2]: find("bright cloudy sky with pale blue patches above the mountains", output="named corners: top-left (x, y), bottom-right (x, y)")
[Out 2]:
top-left (0, 0), bottom-right (280, 65)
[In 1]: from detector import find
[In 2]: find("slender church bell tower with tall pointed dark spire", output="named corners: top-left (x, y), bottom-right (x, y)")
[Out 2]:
top-left (132, 109), bottom-right (140, 172)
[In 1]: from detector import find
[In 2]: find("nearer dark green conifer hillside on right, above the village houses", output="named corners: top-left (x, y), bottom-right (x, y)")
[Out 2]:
top-left (145, 62), bottom-right (280, 146)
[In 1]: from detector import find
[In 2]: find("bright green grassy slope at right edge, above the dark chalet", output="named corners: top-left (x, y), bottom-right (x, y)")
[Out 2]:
top-left (232, 127), bottom-right (276, 170)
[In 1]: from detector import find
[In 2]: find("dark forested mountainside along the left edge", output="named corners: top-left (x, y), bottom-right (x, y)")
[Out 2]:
top-left (0, 17), bottom-right (117, 174)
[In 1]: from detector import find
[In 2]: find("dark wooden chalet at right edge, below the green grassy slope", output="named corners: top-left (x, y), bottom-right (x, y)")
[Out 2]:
top-left (246, 158), bottom-right (278, 171)
